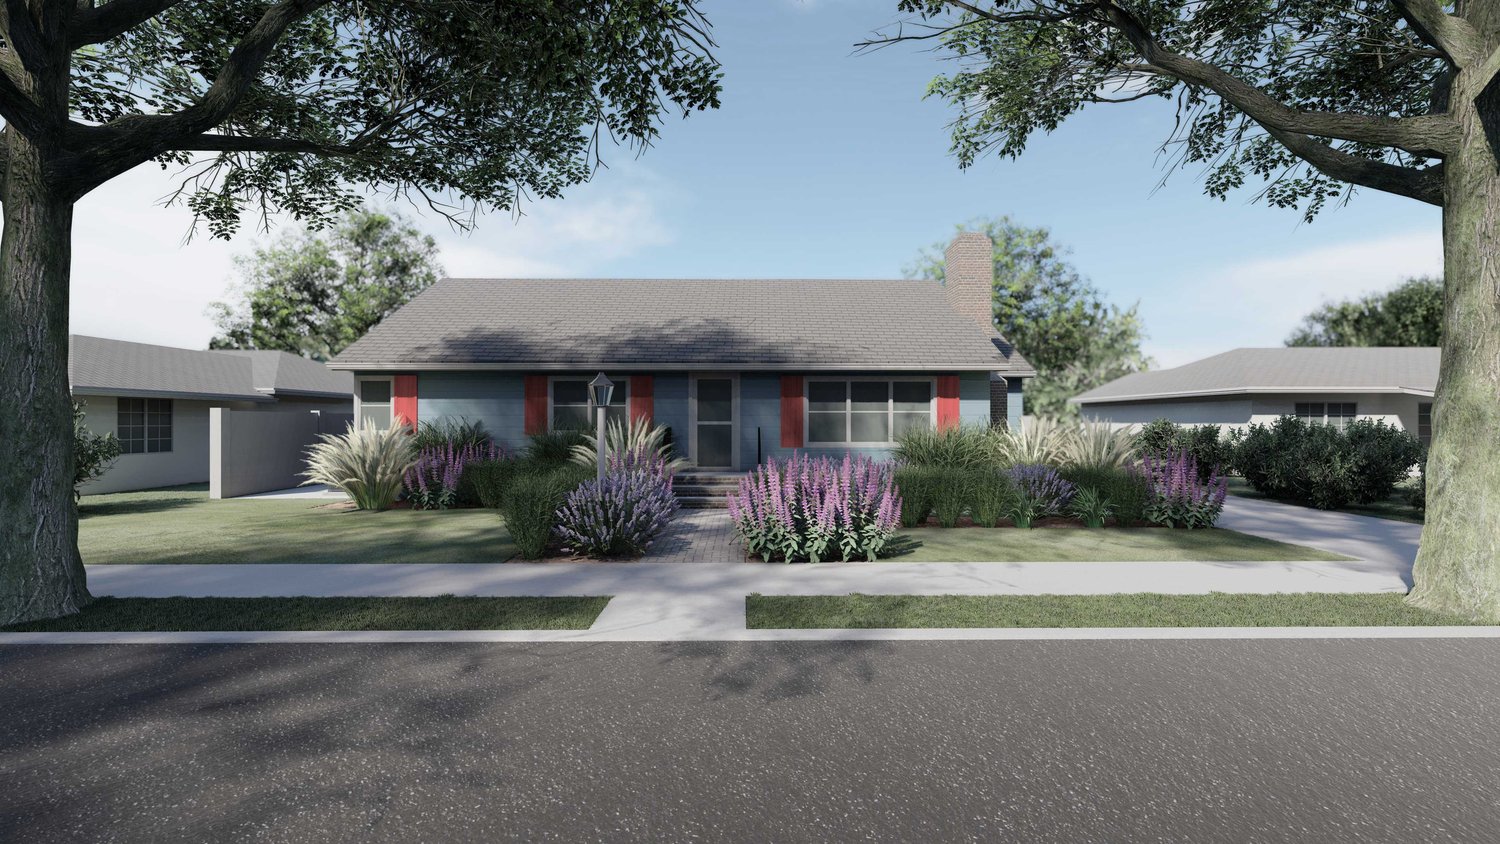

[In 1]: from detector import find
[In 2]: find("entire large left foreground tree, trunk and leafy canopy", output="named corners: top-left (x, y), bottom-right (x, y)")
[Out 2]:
top-left (0, 0), bottom-right (720, 624)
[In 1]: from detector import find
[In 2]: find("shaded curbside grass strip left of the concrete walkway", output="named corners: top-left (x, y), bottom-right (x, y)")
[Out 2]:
top-left (0, 595), bottom-right (609, 633)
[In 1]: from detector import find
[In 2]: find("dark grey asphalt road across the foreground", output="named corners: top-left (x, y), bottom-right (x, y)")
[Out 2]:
top-left (0, 640), bottom-right (1500, 843)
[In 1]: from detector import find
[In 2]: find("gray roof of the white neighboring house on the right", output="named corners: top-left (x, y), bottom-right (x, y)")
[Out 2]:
top-left (1073, 348), bottom-right (1439, 405)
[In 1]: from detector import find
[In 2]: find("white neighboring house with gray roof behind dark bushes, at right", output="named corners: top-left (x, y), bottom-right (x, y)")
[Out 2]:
top-left (1073, 348), bottom-right (1439, 442)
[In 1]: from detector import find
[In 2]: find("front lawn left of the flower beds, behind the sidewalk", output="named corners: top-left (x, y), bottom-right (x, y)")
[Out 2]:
top-left (78, 486), bottom-right (516, 565)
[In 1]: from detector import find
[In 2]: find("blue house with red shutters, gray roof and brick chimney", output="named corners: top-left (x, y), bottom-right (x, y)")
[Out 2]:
top-left (330, 234), bottom-right (1035, 469)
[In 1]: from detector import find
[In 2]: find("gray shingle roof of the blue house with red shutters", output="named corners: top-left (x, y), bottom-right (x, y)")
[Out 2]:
top-left (332, 279), bottom-right (1032, 375)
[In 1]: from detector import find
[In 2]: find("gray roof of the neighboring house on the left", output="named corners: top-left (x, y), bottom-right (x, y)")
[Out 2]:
top-left (68, 334), bottom-right (353, 402)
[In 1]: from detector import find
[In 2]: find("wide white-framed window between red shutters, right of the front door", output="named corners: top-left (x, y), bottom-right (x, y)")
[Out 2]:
top-left (806, 378), bottom-right (938, 445)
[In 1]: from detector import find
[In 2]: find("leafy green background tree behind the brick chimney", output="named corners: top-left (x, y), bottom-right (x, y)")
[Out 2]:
top-left (906, 217), bottom-right (1151, 415)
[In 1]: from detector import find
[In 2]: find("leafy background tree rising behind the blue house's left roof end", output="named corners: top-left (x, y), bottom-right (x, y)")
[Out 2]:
top-left (209, 208), bottom-right (443, 360)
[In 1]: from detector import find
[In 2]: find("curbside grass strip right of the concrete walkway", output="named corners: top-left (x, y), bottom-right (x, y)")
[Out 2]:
top-left (746, 592), bottom-right (1472, 630)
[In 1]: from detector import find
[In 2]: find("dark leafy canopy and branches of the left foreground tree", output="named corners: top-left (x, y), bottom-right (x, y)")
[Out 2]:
top-left (51, 0), bottom-right (719, 237)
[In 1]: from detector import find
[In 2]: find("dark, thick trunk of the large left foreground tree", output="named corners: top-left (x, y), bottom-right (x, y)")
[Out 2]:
top-left (0, 130), bottom-right (92, 624)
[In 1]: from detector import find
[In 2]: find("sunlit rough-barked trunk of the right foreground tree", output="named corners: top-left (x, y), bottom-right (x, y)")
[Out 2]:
top-left (1412, 70), bottom-right (1500, 621)
